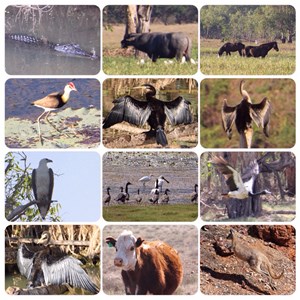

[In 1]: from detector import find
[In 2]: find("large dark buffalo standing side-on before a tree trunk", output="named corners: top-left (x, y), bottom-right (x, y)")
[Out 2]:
top-left (121, 32), bottom-right (192, 62)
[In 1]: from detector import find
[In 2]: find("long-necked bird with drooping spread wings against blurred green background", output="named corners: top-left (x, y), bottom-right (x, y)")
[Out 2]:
top-left (221, 80), bottom-right (271, 148)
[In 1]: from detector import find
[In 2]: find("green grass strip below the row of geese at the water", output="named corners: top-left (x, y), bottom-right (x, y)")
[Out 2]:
top-left (103, 204), bottom-right (198, 222)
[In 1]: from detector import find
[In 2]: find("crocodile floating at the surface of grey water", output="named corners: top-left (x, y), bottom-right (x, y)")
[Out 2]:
top-left (5, 33), bottom-right (99, 59)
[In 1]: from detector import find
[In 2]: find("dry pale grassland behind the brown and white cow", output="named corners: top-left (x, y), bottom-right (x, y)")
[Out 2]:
top-left (102, 224), bottom-right (199, 295)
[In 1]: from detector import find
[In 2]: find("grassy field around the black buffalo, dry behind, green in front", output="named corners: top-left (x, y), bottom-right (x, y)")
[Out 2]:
top-left (103, 24), bottom-right (198, 75)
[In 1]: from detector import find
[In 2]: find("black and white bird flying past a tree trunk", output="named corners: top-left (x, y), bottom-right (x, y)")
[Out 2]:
top-left (211, 156), bottom-right (271, 199)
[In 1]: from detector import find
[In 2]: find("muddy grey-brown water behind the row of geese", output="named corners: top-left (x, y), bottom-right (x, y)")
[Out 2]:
top-left (103, 152), bottom-right (198, 204)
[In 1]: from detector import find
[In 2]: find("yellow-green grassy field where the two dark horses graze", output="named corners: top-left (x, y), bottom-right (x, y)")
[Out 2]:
top-left (200, 39), bottom-right (296, 75)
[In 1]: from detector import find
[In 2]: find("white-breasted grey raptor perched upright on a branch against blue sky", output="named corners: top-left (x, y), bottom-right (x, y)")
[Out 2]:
top-left (31, 158), bottom-right (54, 219)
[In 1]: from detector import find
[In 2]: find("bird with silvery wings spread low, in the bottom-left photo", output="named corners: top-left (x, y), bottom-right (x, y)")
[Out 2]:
top-left (17, 231), bottom-right (99, 294)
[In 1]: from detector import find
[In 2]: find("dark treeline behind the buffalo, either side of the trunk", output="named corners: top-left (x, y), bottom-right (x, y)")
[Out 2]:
top-left (103, 5), bottom-right (198, 27)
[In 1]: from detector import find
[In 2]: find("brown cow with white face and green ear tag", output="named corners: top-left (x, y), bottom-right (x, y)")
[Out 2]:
top-left (106, 230), bottom-right (183, 295)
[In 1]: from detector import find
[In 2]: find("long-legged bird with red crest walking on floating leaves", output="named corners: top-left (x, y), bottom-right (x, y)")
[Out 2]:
top-left (31, 82), bottom-right (77, 143)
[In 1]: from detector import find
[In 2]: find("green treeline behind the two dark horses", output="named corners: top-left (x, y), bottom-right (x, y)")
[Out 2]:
top-left (200, 5), bottom-right (296, 41)
